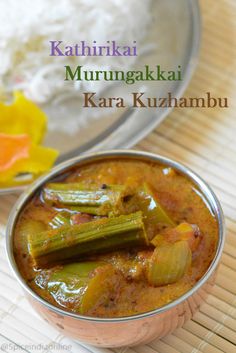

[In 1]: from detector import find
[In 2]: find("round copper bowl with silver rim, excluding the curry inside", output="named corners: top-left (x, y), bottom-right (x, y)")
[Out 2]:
top-left (6, 150), bottom-right (225, 347)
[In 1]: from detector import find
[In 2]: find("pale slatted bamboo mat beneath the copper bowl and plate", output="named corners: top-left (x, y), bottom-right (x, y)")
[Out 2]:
top-left (0, 0), bottom-right (236, 353)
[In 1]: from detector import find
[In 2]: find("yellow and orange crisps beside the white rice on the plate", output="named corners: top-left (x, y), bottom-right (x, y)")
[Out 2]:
top-left (0, 92), bottom-right (58, 186)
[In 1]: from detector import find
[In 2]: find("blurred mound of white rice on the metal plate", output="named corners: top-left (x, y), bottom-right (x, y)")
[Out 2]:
top-left (0, 0), bottom-right (152, 107)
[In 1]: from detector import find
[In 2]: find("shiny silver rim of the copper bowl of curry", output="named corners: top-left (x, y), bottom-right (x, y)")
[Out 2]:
top-left (6, 149), bottom-right (225, 323)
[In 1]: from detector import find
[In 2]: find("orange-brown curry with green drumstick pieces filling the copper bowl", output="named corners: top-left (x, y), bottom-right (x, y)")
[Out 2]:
top-left (13, 158), bottom-right (218, 318)
